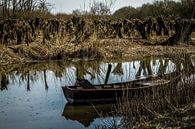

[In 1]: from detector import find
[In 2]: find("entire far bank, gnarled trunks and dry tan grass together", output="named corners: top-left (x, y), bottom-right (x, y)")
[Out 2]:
top-left (0, 16), bottom-right (195, 64)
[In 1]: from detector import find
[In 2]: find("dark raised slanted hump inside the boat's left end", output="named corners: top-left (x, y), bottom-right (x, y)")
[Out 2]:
top-left (76, 78), bottom-right (95, 89)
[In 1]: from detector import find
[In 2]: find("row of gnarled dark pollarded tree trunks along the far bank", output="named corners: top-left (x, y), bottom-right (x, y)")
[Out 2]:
top-left (0, 16), bottom-right (195, 46)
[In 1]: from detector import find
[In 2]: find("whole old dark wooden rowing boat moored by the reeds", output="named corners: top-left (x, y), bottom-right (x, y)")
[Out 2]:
top-left (62, 72), bottom-right (181, 104)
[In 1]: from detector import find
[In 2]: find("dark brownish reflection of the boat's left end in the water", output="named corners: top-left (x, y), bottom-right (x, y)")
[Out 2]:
top-left (62, 104), bottom-right (114, 127)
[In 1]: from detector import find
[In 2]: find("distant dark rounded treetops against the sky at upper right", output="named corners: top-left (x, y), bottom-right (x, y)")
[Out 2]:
top-left (113, 0), bottom-right (195, 19)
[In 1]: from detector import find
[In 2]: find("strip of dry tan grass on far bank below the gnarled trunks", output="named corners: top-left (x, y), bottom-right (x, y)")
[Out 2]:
top-left (0, 39), bottom-right (195, 65)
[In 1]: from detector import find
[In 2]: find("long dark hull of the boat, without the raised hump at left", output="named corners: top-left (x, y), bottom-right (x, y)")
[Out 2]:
top-left (62, 74), bottom-right (181, 104)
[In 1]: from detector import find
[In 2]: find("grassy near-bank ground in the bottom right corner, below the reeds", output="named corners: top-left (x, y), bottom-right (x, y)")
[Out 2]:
top-left (134, 103), bottom-right (195, 129)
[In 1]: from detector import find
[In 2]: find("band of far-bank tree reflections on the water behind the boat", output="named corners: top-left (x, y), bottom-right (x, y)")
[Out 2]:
top-left (0, 55), bottom-right (195, 91)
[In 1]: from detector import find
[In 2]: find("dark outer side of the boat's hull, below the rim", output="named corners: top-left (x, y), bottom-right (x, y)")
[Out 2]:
top-left (62, 85), bottom-right (169, 104)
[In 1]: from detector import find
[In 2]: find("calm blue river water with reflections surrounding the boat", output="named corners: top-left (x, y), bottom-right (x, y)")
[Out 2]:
top-left (0, 56), bottom-right (195, 129)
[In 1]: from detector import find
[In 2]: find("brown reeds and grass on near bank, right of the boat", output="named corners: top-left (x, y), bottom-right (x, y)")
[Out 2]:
top-left (112, 55), bottom-right (195, 128)
